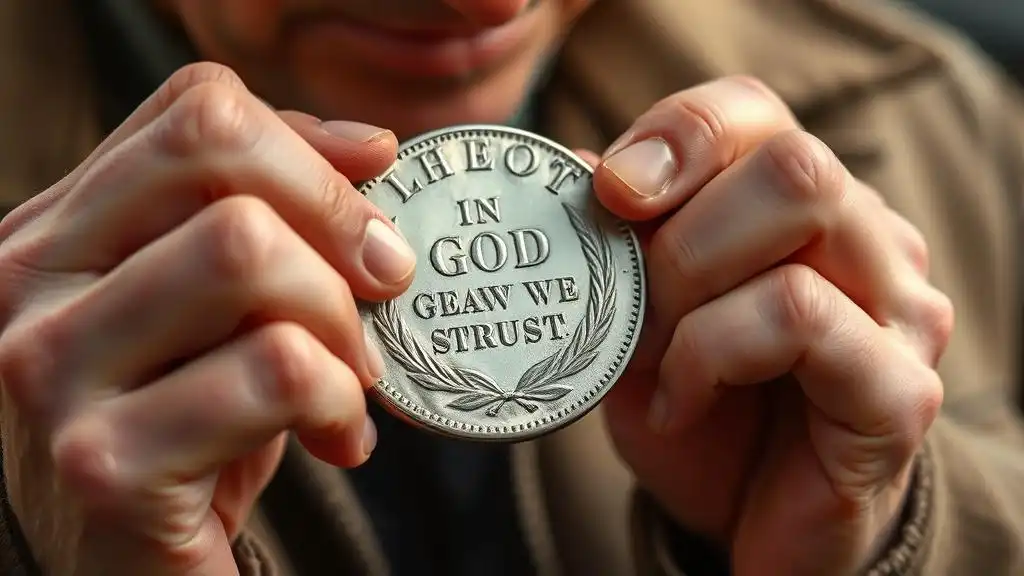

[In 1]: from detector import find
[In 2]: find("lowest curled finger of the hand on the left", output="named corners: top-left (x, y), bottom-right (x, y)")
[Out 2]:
top-left (53, 323), bottom-right (376, 522)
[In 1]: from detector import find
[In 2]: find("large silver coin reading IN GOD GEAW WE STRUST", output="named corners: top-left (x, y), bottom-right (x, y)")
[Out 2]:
top-left (360, 126), bottom-right (645, 442)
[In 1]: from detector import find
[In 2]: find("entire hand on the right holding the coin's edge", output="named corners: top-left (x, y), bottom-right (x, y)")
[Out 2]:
top-left (594, 78), bottom-right (952, 576)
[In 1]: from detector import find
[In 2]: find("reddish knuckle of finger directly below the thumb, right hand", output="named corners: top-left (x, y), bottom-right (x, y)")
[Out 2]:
top-left (762, 130), bottom-right (847, 205)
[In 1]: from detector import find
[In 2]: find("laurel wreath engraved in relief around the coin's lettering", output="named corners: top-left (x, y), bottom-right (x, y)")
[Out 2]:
top-left (373, 204), bottom-right (615, 416)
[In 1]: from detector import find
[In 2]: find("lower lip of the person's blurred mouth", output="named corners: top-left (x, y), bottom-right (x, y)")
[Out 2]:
top-left (294, 9), bottom-right (540, 78)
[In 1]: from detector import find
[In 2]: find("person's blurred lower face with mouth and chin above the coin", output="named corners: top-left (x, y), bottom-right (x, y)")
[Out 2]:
top-left (162, 0), bottom-right (592, 137)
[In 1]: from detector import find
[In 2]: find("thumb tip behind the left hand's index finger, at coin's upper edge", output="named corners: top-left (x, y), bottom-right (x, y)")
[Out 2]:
top-left (278, 111), bottom-right (398, 182)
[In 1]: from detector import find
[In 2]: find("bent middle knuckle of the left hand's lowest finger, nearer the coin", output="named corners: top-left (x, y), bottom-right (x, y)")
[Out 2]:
top-left (249, 322), bottom-right (321, 410)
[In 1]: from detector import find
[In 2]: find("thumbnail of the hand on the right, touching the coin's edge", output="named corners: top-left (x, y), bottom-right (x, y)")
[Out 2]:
top-left (604, 138), bottom-right (679, 198)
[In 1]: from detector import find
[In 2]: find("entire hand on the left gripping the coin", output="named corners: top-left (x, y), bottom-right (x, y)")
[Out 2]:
top-left (0, 65), bottom-right (415, 576)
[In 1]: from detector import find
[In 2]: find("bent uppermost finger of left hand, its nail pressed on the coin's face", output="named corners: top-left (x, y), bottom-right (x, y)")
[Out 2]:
top-left (42, 72), bottom-right (415, 299)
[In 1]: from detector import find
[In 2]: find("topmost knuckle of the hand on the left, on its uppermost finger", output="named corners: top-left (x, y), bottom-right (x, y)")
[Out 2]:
top-left (158, 82), bottom-right (260, 156)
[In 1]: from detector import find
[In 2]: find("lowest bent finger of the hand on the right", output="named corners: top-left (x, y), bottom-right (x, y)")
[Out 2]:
top-left (650, 264), bottom-right (942, 479)
